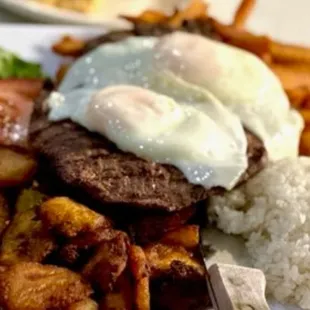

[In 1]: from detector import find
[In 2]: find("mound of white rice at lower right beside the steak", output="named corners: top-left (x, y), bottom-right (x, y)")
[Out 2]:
top-left (209, 157), bottom-right (310, 309)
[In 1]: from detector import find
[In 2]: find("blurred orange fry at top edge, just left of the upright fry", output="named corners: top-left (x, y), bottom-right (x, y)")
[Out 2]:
top-left (169, 0), bottom-right (207, 27)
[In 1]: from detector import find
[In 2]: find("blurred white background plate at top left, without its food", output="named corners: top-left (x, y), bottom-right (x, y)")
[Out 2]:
top-left (0, 0), bottom-right (180, 28)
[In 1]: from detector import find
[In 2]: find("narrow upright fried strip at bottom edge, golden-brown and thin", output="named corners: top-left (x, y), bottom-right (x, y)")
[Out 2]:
top-left (129, 245), bottom-right (151, 310)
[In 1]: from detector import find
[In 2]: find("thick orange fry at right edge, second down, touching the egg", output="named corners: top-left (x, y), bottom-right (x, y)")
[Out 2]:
top-left (270, 63), bottom-right (310, 89)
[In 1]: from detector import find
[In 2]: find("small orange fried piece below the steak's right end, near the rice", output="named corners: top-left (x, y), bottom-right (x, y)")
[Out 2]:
top-left (160, 225), bottom-right (199, 249)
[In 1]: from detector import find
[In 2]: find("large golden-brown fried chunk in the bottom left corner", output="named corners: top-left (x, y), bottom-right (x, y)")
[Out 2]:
top-left (0, 263), bottom-right (92, 310)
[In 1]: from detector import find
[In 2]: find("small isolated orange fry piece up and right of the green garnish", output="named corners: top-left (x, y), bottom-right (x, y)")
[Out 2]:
top-left (52, 35), bottom-right (86, 57)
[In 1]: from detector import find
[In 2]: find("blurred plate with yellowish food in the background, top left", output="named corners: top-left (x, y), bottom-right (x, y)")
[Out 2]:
top-left (0, 0), bottom-right (179, 28)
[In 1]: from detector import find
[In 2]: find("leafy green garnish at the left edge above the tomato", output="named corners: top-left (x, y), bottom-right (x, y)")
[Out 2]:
top-left (0, 48), bottom-right (44, 79)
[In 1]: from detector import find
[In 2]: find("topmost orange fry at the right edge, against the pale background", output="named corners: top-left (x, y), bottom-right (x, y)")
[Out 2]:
top-left (270, 42), bottom-right (310, 64)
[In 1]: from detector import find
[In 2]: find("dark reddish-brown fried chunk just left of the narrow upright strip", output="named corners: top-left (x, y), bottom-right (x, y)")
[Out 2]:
top-left (82, 232), bottom-right (129, 293)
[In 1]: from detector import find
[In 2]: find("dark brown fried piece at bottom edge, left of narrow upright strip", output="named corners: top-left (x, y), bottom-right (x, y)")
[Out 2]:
top-left (99, 273), bottom-right (134, 310)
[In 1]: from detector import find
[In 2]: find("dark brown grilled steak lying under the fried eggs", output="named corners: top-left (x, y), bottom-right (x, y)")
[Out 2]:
top-left (31, 110), bottom-right (265, 211)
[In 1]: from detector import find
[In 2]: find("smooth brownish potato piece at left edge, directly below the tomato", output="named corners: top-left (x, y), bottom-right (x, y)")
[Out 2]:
top-left (0, 147), bottom-right (36, 187)
